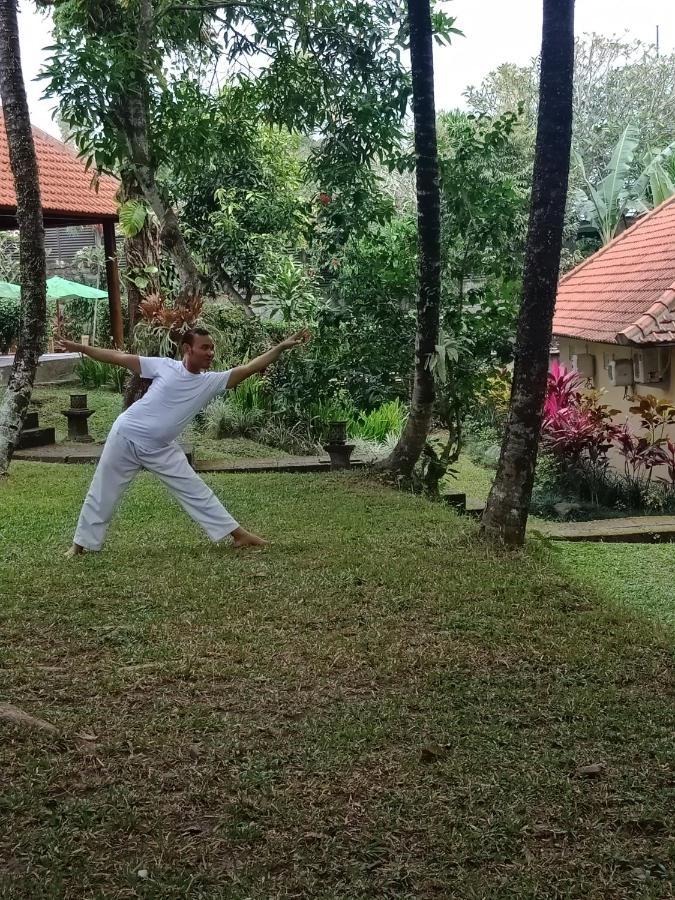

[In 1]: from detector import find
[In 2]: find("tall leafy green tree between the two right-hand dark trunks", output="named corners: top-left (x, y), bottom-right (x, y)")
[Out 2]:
top-left (430, 113), bottom-right (528, 464)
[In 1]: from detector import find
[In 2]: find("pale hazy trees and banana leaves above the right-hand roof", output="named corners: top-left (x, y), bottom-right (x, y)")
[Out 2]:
top-left (466, 34), bottom-right (675, 251)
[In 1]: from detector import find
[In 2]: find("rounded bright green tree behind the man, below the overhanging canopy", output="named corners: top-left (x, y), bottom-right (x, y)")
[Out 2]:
top-left (165, 94), bottom-right (309, 300)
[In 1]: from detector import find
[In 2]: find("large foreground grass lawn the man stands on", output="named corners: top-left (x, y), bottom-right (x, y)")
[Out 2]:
top-left (0, 463), bottom-right (674, 900)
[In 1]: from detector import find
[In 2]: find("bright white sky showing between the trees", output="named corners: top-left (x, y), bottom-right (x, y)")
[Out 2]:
top-left (19, 0), bottom-right (675, 137)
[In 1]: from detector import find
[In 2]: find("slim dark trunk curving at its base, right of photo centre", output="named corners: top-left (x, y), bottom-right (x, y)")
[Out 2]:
top-left (383, 0), bottom-right (441, 477)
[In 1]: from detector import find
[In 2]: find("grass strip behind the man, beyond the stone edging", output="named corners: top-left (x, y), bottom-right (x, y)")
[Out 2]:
top-left (23, 384), bottom-right (288, 460)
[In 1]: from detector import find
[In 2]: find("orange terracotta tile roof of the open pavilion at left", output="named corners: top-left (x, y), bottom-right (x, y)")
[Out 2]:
top-left (0, 108), bottom-right (118, 218)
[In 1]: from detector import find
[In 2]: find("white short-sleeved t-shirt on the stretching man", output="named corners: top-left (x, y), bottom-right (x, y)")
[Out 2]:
top-left (116, 356), bottom-right (232, 450)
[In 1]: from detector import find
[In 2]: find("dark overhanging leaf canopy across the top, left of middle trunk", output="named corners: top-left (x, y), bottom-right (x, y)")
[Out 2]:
top-left (45, 0), bottom-right (453, 207)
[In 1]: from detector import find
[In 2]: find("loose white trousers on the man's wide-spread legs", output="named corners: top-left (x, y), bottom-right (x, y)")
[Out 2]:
top-left (73, 425), bottom-right (238, 550)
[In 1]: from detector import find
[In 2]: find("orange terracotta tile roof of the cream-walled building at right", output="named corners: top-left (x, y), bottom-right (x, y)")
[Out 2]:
top-left (553, 197), bottom-right (675, 344)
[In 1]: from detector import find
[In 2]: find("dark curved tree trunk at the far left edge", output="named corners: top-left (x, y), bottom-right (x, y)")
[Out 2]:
top-left (0, 0), bottom-right (47, 475)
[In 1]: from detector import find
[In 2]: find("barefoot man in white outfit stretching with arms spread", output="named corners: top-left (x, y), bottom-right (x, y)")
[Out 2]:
top-left (56, 328), bottom-right (309, 556)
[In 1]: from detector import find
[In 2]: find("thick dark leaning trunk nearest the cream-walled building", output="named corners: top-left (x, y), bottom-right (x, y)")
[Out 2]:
top-left (482, 0), bottom-right (574, 547)
